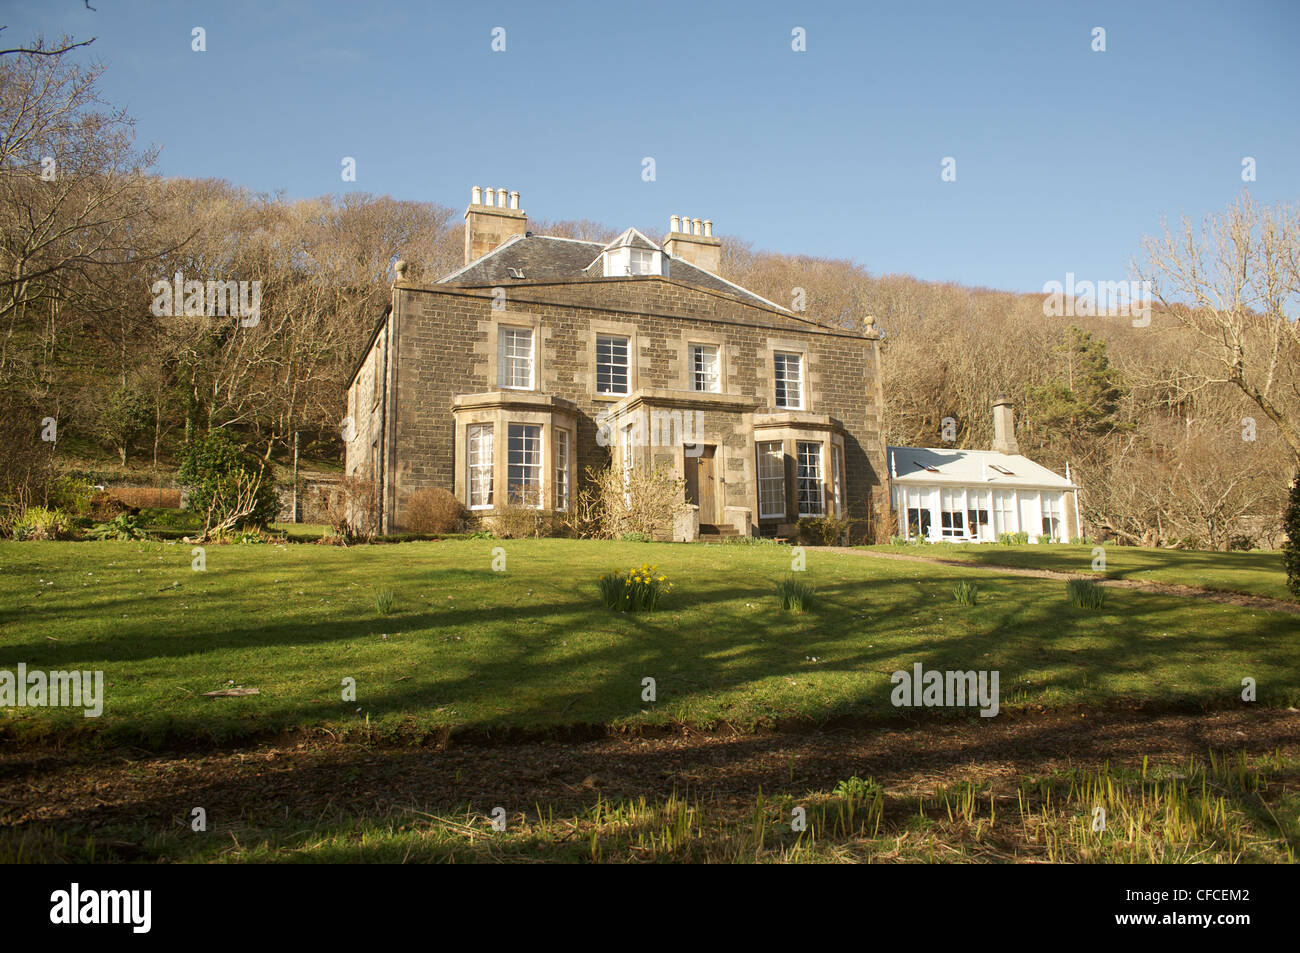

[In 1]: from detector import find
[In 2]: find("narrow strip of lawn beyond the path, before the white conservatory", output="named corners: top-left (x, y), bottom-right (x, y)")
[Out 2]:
top-left (866, 542), bottom-right (1292, 599)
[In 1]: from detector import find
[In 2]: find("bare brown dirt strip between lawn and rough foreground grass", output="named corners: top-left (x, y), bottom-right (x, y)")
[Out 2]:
top-left (0, 709), bottom-right (1300, 831)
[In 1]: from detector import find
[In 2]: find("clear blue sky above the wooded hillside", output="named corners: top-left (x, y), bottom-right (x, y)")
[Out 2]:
top-left (0, 0), bottom-right (1300, 291)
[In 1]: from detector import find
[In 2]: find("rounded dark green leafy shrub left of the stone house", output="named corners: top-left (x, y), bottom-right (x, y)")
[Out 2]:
top-left (177, 429), bottom-right (280, 538)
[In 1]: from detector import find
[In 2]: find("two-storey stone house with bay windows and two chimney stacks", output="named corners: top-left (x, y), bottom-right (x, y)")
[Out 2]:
top-left (345, 187), bottom-right (888, 540)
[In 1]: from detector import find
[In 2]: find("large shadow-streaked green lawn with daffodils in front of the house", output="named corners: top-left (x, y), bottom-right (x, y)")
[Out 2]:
top-left (0, 540), bottom-right (1300, 745)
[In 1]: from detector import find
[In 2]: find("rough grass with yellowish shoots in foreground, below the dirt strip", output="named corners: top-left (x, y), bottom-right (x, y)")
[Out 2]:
top-left (0, 753), bottom-right (1300, 863)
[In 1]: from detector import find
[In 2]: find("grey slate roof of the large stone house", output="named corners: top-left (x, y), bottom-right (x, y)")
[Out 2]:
top-left (438, 229), bottom-right (790, 312)
